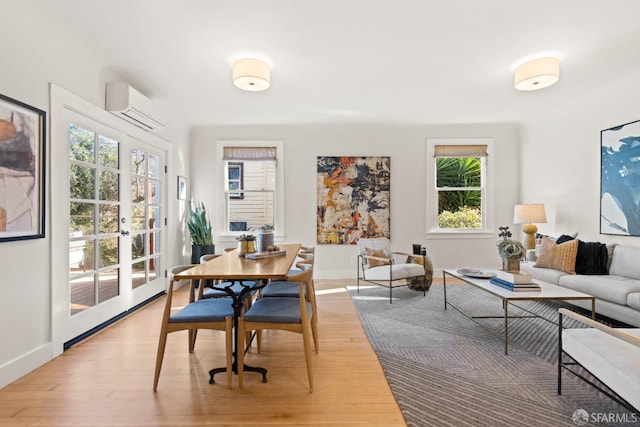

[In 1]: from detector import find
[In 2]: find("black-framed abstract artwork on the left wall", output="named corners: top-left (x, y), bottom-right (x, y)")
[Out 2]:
top-left (0, 95), bottom-right (46, 242)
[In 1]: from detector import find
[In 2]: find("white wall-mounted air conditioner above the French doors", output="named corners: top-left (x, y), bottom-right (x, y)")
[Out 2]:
top-left (105, 82), bottom-right (164, 132)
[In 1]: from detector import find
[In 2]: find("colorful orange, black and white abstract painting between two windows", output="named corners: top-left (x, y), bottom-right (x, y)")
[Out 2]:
top-left (317, 156), bottom-right (391, 245)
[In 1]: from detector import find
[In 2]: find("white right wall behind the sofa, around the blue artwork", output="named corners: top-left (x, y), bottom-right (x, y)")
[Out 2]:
top-left (521, 65), bottom-right (640, 246)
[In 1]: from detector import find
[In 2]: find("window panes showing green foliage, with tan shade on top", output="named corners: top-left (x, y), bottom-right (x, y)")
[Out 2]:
top-left (435, 145), bottom-right (486, 230)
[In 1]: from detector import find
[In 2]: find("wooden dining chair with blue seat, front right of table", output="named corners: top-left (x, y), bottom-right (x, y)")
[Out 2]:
top-left (238, 266), bottom-right (314, 391)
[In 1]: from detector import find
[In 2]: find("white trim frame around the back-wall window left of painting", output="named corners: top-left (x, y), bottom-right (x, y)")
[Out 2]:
top-left (214, 140), bottom-right (285, 242)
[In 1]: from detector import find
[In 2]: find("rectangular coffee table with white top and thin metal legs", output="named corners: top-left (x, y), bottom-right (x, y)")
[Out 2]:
top-left (442, 269), bottom-right (596, 354)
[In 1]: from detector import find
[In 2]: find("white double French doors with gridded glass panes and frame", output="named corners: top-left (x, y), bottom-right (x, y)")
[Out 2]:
top-left (54, 109), bottom-right (166, 350)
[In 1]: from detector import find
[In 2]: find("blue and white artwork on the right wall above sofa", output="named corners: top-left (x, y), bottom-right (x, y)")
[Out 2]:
top-left (600, 120), bottom-right (640, 236)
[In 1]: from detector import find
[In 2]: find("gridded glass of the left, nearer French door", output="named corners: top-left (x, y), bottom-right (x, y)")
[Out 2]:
top-left (69, 124), bottom-right (120, 315)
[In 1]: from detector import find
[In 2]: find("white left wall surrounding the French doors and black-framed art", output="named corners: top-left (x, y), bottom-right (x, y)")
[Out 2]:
top-left (0, 2), bottom-right (189, 387)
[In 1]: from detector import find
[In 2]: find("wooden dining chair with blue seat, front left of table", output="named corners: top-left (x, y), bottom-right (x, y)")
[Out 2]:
top-left (153, 265), bottom-right (233, 391)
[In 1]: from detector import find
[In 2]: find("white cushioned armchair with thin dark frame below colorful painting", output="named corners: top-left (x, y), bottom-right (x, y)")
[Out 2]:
top-left (356, 237), bottom-right (426, 303)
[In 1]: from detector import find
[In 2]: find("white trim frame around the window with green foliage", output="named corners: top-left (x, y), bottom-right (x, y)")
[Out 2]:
top-left (425, 138), bottom-right (495, 238)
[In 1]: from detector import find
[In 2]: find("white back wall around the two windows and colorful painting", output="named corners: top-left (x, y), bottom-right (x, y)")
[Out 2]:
top-left (191, 125), bottom-right (520, 278)
